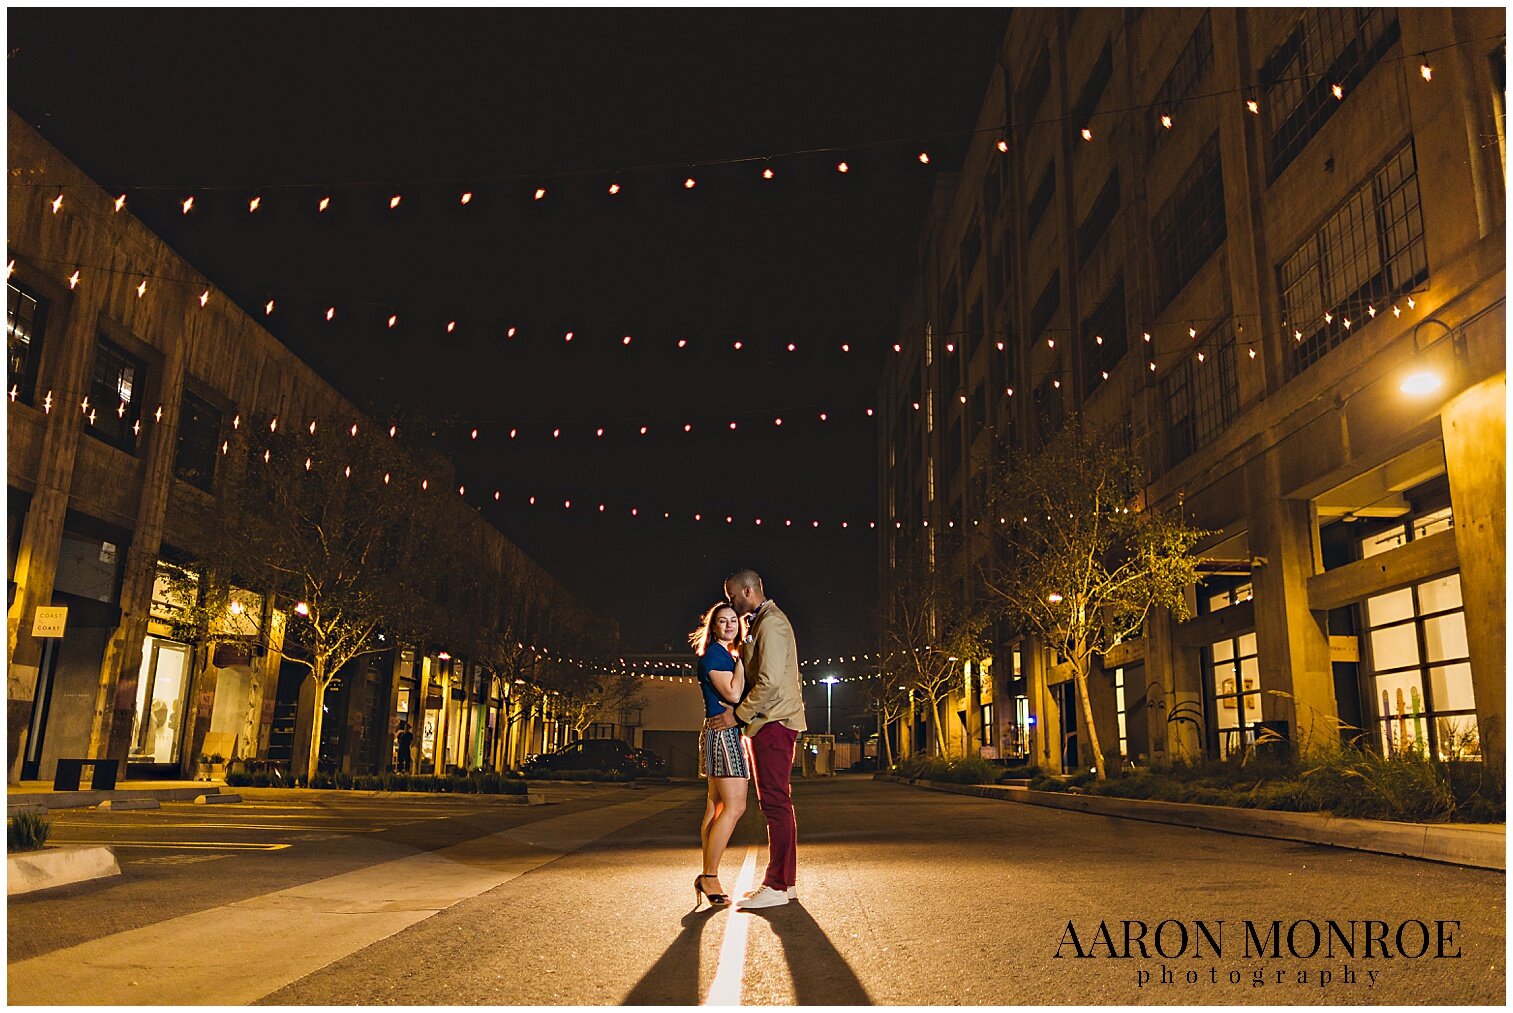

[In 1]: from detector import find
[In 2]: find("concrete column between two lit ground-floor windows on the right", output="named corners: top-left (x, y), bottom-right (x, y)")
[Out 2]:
top-left (1247, 454), bottom-right (1339, 754)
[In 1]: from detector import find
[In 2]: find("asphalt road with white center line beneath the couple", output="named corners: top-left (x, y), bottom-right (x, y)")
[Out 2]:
top-left (8, 777), bottom-right (1505, 1005)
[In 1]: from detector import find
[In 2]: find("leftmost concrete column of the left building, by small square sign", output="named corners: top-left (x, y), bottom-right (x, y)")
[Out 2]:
top-left (6, 273), bottom-right (99, 785)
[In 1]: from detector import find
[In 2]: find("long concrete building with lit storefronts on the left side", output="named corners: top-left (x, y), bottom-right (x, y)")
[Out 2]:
top-left (6, 113), bottom-right (608, 779)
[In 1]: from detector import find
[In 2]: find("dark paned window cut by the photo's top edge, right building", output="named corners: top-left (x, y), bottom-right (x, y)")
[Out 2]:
top-left (1260, 8), bottom-right (1398, 181)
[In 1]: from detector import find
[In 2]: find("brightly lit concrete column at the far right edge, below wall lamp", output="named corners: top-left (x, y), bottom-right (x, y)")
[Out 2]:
top-left (1440, 373), bottom-right (1507, 768)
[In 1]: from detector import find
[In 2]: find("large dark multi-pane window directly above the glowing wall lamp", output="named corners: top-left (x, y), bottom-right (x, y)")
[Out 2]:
top-left (1277, 141), bottom-right (1428, 373)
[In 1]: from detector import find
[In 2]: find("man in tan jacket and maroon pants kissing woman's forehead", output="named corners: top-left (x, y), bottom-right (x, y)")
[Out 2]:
top-left (705, 570), bottom-right (808, 909)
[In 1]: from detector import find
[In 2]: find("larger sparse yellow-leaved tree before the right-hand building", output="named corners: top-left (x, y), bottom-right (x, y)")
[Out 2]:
top-left (985, 419), bottom-right (1209, 780)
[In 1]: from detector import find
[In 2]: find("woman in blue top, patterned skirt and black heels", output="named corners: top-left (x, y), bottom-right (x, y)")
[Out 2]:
top-left (688, 602), bottom-right (750, 907)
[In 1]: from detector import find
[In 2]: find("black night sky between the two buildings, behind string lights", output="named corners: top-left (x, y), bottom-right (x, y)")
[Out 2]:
top-left (8, 9), bottom-right (1008, 677)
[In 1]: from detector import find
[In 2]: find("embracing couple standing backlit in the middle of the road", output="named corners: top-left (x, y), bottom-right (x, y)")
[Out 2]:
top-left (688, 570), bottom-right (808, 909)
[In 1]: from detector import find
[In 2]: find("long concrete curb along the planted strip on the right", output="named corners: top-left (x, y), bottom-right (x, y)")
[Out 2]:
top-left (878, 774), bottom-right (1507, 872)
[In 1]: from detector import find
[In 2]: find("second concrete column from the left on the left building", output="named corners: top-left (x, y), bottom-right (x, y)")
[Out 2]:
top-left (89, 312), bottom-right (195, 762)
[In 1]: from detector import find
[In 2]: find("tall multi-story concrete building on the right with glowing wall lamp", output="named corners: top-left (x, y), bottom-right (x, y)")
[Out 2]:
top-left (879, 8), bottom-right (1507, 770)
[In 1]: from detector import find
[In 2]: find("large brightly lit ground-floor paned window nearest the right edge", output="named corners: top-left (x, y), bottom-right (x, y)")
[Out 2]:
top-left (1360, 508), bottom-right (1481, 761)
